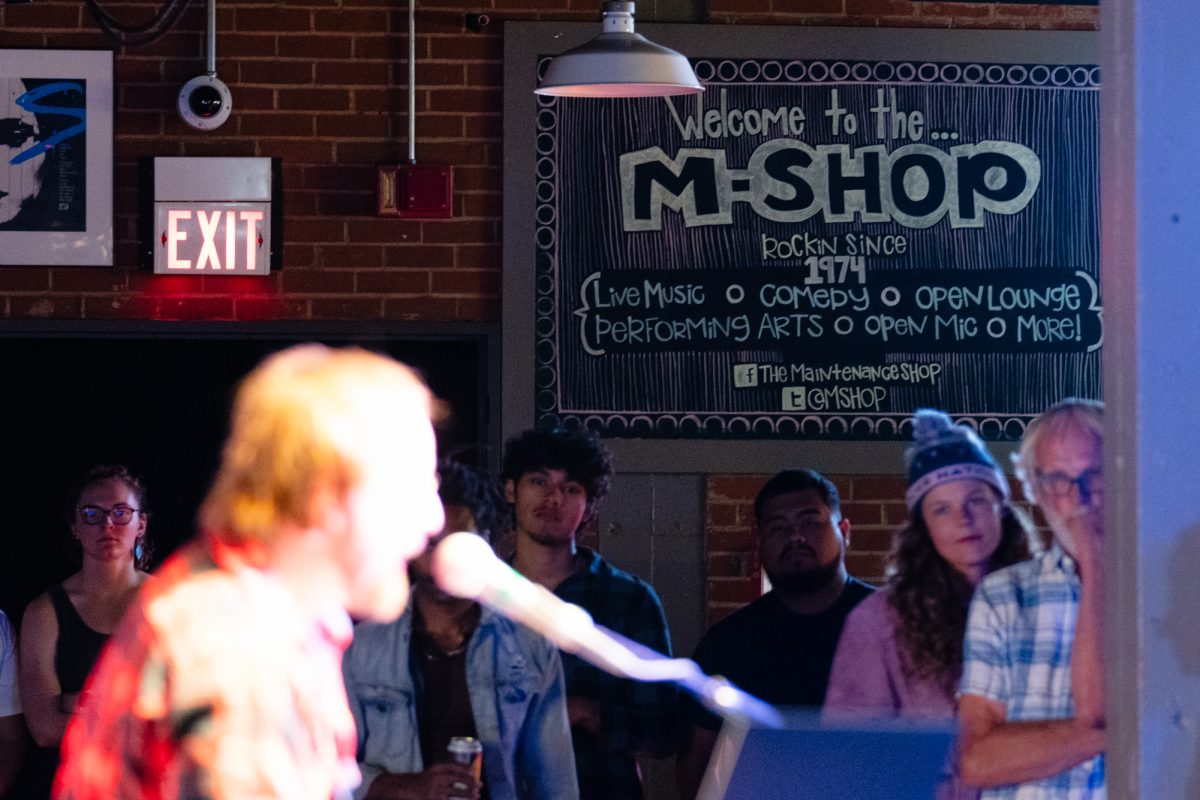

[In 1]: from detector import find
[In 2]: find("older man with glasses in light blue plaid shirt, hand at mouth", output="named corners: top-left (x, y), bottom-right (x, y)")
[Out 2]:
top-left (959, 399), bottom-right (1105, 800)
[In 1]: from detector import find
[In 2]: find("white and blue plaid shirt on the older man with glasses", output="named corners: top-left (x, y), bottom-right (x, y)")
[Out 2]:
top-left (960, 542), bottom-right (1106, 800)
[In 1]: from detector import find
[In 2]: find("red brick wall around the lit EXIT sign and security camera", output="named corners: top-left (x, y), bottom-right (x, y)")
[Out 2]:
top-left (0, 0), bottom-right (1097, 323)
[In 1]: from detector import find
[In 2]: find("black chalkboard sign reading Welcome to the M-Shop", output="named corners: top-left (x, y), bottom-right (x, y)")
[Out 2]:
top-left (509, 29), bottom-right (1103, 440)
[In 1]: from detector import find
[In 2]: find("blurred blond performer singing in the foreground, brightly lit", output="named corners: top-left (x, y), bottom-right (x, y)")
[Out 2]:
top-left (55, 345), bottom-right (443, 800)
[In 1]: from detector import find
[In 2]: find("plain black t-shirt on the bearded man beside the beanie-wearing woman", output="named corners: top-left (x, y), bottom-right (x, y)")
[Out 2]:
top-left (692, 578), bottom-right (874, 729)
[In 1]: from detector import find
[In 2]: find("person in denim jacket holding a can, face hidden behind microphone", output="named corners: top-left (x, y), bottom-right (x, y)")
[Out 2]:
top-left (343, 462), bottom-right (578, 800)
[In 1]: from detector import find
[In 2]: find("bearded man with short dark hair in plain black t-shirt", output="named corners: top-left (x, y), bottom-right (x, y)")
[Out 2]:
top-left (676, 469), bottom-right (872, 800)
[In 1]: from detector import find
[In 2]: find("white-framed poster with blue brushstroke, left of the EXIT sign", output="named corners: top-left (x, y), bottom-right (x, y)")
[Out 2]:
top-left (0, 49), bottom-right (113, 266)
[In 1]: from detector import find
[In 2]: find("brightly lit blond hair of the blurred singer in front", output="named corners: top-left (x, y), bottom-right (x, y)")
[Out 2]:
top-left (198, 344), bottom-right (438, 543)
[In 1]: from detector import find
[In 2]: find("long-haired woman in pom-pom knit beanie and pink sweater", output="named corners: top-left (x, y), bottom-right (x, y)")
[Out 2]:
top-left (824, 409), bottom-right (1038, 800)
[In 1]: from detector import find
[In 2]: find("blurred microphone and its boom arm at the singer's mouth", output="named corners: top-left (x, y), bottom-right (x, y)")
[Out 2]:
top-left (431, 531), bottom-right (784, 728)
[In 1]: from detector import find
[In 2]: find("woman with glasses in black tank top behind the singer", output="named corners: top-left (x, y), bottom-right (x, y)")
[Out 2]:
top-left (20, 465), bottom-right (150, 798)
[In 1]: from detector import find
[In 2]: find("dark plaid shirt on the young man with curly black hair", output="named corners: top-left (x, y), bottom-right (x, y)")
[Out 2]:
top-left (554, 547), bottom-right (676, 800)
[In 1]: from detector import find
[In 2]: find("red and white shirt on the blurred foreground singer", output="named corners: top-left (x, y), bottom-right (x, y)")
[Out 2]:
top-left (54, 542), bottom-right (359, 800)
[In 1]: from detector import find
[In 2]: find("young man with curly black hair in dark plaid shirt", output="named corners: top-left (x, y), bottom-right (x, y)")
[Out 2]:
top-left (502, 428), bottom-right (676, 800)
